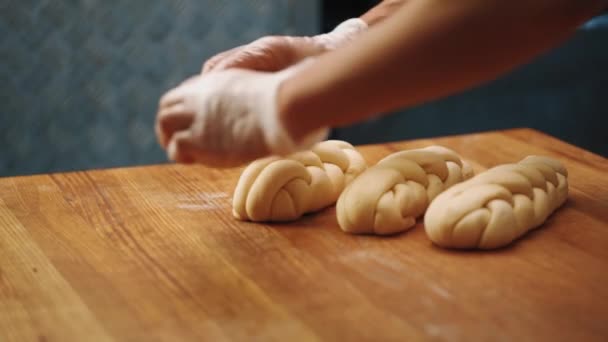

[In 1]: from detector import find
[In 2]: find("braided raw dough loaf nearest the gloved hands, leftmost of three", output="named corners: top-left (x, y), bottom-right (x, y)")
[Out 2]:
top-left (232, 140), bottom-right (367, 222)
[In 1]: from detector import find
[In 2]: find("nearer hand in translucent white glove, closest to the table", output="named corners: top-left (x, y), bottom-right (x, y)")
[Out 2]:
top-left (156, 61), bottom-right (327, 167)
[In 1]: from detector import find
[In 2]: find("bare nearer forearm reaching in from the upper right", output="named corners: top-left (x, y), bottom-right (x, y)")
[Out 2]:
top-left (278, 0), bottom-right (601, 138)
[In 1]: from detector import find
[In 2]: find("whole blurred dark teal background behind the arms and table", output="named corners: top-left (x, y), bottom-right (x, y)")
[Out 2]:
top-left (0, 0), bottom-right (608, 176)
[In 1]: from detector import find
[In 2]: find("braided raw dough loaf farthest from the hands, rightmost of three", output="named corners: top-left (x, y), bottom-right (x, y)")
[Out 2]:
top-left (424, 156), bottom-right (568, 249)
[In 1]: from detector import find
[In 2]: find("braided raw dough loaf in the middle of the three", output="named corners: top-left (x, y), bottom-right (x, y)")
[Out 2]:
top-left (336, 146), bottom-right (473, 234)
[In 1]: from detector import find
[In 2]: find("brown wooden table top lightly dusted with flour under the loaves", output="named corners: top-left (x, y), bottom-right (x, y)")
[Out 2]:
top-left (0, 129), bottom-right (608, 341)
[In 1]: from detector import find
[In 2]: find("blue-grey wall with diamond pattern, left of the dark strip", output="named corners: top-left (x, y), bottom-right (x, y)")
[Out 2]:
top-left (0, 0), bottom-right (319, 176)
